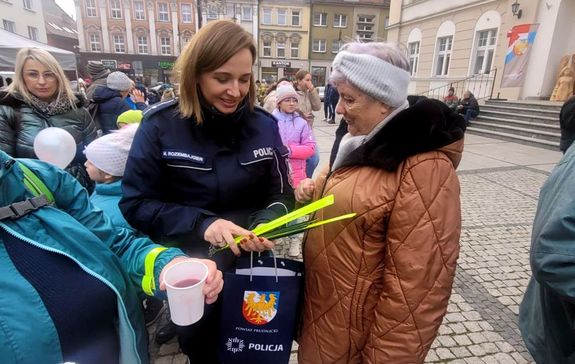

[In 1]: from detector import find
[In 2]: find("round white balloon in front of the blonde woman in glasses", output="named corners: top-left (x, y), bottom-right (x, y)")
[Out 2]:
top-left (34, 128), bottom-right (76, 169)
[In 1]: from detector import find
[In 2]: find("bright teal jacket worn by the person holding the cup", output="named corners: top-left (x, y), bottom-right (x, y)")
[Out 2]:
top-left (0, 151), bottom-right (183, 364)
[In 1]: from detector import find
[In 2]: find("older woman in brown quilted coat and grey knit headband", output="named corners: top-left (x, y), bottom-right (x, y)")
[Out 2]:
top-left (296, 43), bottom-right (465, 364)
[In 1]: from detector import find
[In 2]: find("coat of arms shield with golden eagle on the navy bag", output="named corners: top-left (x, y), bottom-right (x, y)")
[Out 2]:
top-left (242, 291), bottom-right (280, 325)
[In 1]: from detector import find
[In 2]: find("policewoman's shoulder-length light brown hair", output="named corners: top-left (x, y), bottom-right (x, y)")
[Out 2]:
top-left (174, 20), bottom-right (256, 124)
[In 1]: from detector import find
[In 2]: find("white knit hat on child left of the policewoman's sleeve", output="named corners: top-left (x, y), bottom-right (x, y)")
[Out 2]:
top-left (84, 124), bottom-right (139, 177)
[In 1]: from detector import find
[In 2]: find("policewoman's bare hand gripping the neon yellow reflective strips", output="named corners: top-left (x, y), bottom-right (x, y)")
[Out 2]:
top-left (204, 219), bottom-right (274, 256)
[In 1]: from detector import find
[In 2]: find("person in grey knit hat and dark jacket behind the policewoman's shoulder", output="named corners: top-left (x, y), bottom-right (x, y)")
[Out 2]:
top-left (93, 71), bottom-right (148, 134)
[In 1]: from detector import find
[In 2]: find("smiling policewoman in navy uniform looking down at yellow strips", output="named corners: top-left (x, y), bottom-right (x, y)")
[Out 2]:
top-left (120, 21), bottom-right (293, 364)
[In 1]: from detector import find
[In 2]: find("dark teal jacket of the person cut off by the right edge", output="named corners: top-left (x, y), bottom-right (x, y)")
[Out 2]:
top-left (519, 146), bottom-right (575, 364)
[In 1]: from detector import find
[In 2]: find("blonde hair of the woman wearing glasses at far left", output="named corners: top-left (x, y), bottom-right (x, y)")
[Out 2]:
top-left (6, 48), bottom-right (78, 109)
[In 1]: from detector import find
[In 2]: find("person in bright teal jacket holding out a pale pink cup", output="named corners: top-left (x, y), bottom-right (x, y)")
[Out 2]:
top-left (0, 151), bottom-right (223, 364)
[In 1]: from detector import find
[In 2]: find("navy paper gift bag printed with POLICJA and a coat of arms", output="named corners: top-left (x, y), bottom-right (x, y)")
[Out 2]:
top-left (218, 254), bottom-right (303, 364)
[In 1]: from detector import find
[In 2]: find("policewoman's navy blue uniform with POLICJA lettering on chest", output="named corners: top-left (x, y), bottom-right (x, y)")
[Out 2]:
top-left (120, 99), bottom-right (294, 364)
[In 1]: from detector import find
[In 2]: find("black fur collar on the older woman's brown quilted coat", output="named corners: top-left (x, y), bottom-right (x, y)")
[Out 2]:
top-left (330, 96), bottom-right (465, 171)
